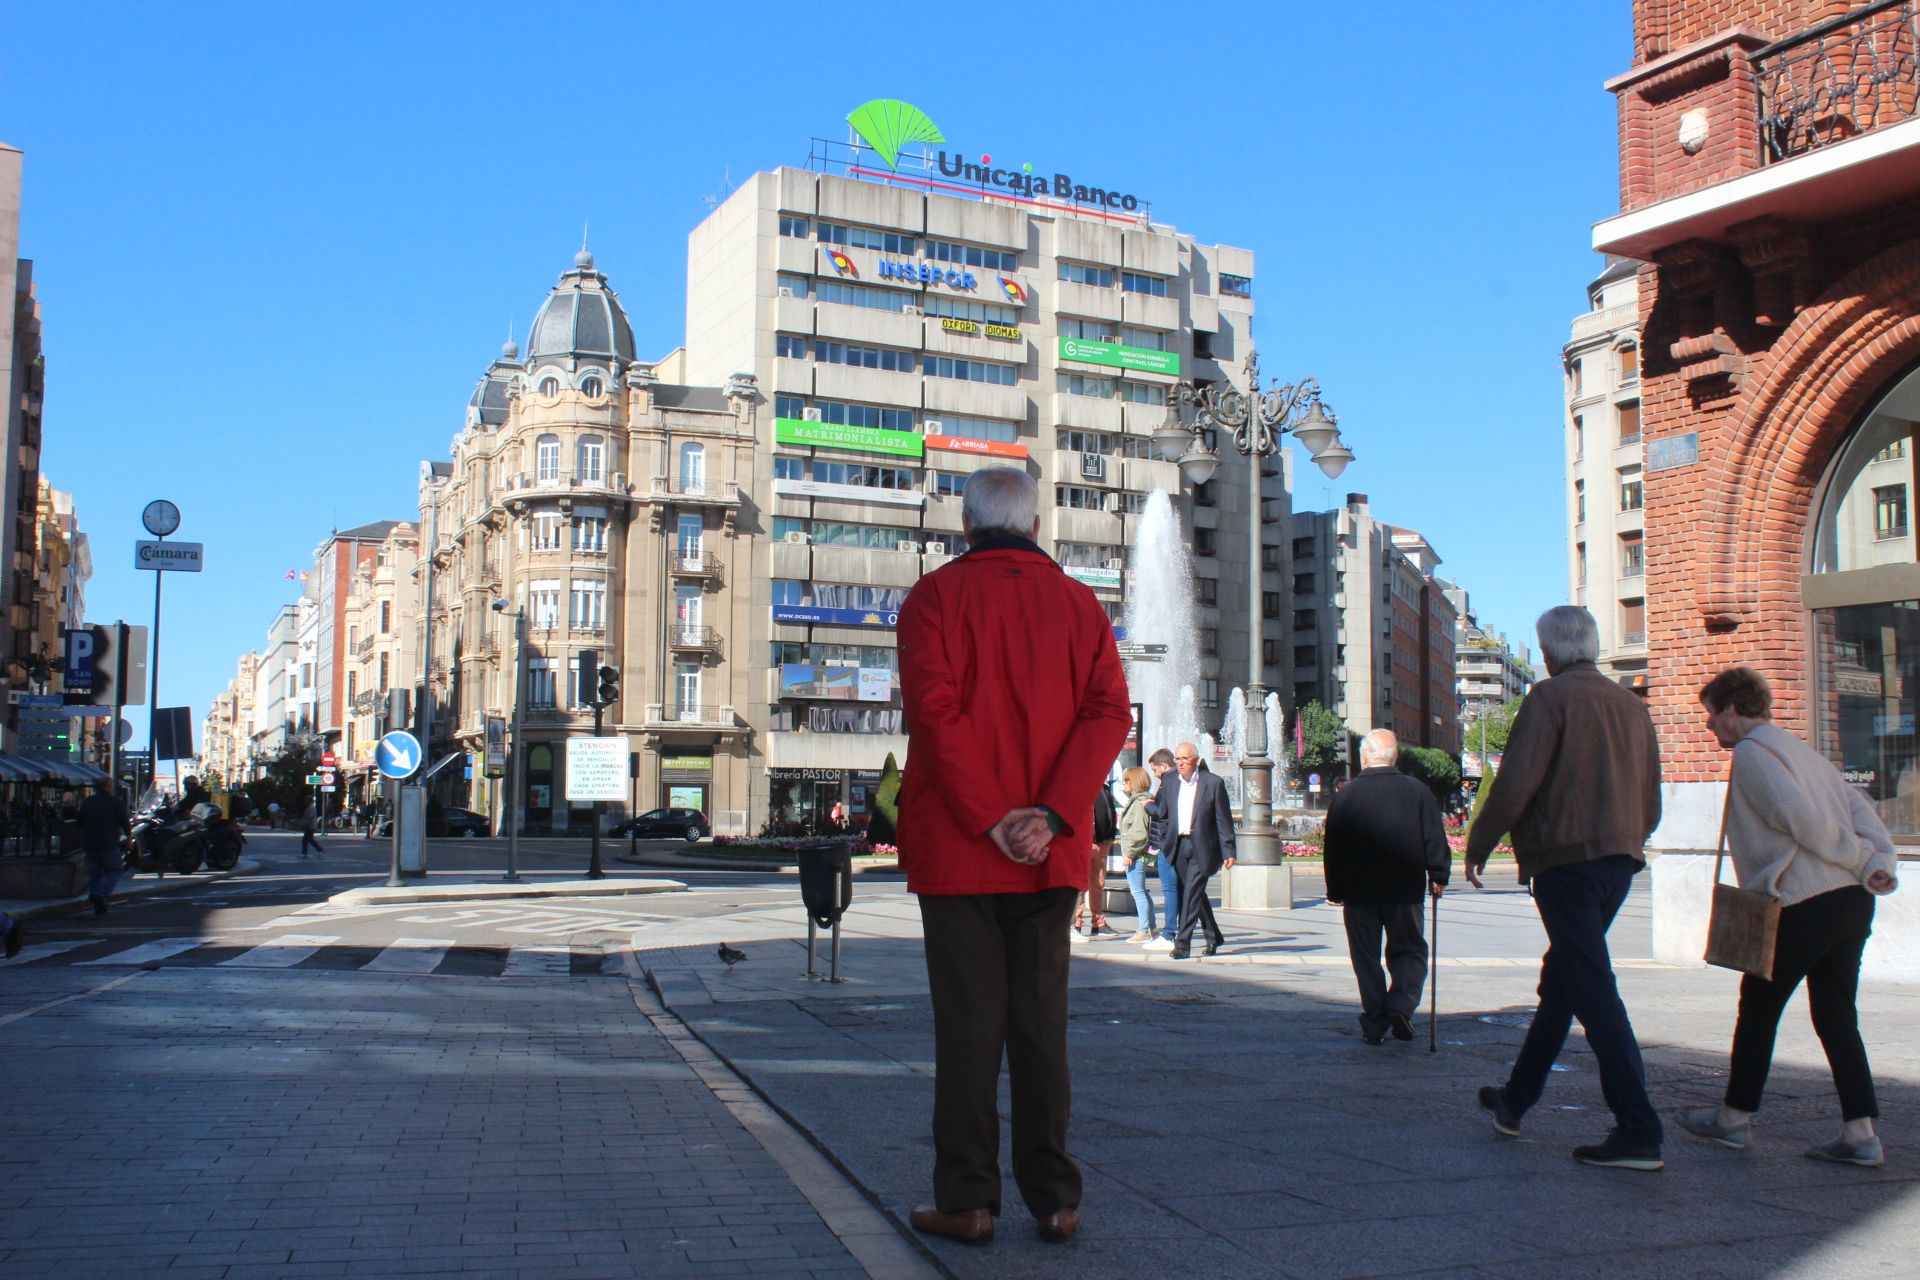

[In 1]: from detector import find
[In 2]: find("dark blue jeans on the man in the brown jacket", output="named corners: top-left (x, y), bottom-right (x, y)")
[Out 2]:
top-left (1507, 854), bottom-right (1661, 1144)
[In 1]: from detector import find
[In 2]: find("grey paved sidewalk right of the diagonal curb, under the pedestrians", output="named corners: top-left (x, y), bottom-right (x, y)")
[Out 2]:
top-left (636, 887), bottom-right (1920, 1280)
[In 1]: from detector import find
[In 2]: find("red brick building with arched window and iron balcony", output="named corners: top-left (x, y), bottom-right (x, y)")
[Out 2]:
top-left (1594, 0), bottom-right (1920, 848)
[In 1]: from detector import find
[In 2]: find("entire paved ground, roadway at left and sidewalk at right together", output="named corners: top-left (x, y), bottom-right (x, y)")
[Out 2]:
top-left (0, 841), bottom-right (1920, 1280)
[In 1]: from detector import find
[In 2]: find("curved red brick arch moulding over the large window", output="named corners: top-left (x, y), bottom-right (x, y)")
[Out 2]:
top-left (1697, 240), bottom-right (1920, 629)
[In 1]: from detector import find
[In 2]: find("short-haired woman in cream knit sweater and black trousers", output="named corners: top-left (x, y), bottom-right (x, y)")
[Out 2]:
top-left (1676, 666), bottom-right (1895, 1167)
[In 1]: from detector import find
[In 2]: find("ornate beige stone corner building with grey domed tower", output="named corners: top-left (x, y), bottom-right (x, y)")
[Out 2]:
top-left (420, 248), bottom-right (758, 835)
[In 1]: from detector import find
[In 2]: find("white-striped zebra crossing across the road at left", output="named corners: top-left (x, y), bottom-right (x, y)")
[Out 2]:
top-left (0, 933), bottom-right (609, 979)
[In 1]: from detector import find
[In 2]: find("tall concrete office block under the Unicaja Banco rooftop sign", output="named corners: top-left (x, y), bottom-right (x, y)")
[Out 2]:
top-left (682, 169), bottom-right (1290, 829)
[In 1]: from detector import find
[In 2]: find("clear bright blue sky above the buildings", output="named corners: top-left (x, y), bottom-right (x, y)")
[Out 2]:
top-left (0, 0), bottom-right (1630, 741)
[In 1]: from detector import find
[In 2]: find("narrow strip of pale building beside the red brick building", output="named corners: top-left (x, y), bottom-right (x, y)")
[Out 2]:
top-left (1561, 257), bottom-right (1647, 691)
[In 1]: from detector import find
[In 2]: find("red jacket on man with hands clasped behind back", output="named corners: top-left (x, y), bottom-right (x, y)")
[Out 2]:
top-left (899, 539), bottom-right (1133, 894)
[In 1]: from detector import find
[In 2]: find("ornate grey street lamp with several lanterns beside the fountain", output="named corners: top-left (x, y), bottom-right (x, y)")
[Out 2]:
top-left (1154, 351), bottom-right (1354, 865)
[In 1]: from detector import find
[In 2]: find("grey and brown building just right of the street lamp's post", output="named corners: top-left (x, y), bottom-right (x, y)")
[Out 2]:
top-left (1290, 493), bottom-right (1459, 767)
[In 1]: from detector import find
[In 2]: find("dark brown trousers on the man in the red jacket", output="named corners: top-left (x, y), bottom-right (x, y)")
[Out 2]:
top-left (920, 889), bottom-right (1081, 1219)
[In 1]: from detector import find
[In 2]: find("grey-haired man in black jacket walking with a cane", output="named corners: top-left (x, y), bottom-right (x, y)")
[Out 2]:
top-left (1325, 729), bottom-right (1453, 1044)
